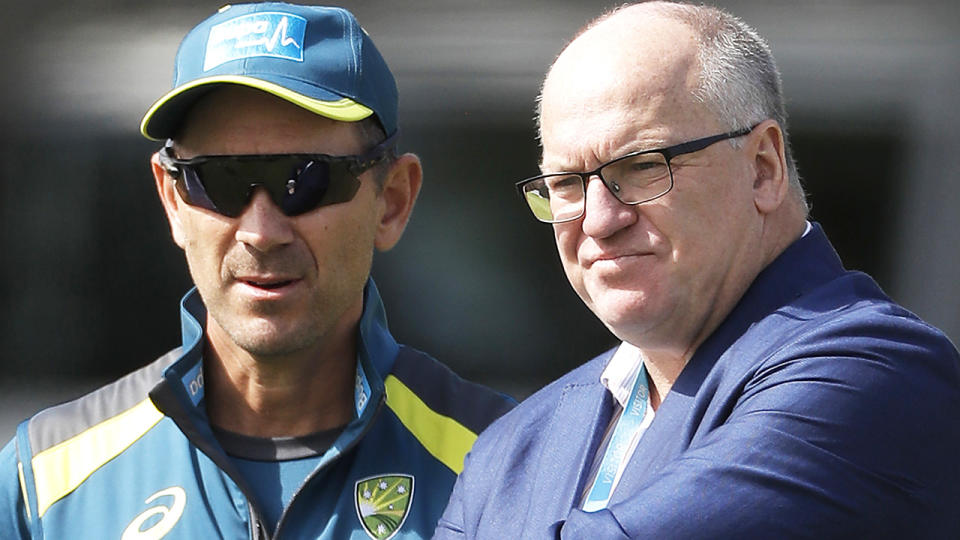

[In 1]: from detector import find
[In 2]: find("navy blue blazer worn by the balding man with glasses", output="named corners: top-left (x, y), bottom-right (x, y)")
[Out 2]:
top-left (435, 226), bottom-right (960, 539)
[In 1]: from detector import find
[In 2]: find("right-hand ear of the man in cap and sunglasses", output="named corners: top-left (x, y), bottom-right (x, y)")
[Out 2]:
top-left (374, 154), bottom-right (423, 251)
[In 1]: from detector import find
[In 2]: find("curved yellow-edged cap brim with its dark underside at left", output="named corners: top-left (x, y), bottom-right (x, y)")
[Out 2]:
top-left (140, 75), bottom-right (373, 141)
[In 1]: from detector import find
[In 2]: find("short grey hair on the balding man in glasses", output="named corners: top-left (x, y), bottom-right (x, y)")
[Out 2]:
top-left (537, 0), bottom-right (809, 209)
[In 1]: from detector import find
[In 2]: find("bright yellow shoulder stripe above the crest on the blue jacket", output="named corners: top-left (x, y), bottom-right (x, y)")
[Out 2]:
top-left (383, 375), bottom-right (477, 474)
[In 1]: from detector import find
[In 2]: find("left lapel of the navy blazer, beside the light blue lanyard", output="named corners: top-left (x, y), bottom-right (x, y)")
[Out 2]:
top-left (523, 381), bottom-right (613, 536)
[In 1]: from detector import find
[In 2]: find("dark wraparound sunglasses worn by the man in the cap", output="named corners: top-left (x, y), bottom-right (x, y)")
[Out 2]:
top-left (159, 132), bottom-right (399, 217)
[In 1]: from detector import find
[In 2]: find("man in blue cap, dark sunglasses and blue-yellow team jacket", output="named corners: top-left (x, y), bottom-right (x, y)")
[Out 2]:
top-left (0, 3), bottom-right (511, 540)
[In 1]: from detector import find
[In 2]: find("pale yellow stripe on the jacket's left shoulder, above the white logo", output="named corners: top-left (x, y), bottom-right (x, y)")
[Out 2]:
top-left (31, 398), bottom-right (163, 517)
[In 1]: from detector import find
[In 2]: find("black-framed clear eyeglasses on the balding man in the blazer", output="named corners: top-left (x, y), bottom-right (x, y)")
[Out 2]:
top-left (517, 126), bottom-right (756, 223)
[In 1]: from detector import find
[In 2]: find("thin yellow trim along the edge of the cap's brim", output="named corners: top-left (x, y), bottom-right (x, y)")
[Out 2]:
top-left (140, 75), bottom-right (373, 140)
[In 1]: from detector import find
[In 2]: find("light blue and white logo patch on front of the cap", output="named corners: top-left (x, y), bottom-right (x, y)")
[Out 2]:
top-left (203, 12), bottom-right (307, 71)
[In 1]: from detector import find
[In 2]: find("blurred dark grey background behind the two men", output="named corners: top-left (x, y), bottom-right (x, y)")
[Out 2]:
top-left (0, 0), bottom-right (960, 444)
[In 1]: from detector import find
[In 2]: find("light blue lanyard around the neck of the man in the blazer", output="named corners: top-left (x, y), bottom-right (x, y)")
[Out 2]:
top-left (583, 363), bottom-right (650, 512)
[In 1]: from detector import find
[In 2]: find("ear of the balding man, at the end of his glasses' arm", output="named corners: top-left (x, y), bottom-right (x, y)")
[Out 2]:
top-left (748, 120), bottom-right (790, 214)
